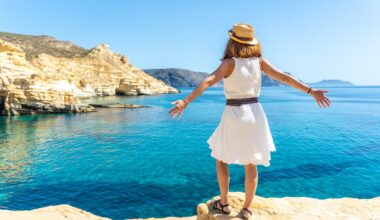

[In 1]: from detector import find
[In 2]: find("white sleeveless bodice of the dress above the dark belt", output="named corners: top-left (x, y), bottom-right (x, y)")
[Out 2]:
top-left (223, 57), bottom-right (261, 99)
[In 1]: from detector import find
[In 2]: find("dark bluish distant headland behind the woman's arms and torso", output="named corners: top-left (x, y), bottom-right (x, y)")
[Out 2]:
top-left (144, 68), bottom-right (290, 88)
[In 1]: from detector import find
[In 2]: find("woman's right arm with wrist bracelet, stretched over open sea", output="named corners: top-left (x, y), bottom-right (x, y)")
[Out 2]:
top-left (260, 59), bottom-right (331, 108)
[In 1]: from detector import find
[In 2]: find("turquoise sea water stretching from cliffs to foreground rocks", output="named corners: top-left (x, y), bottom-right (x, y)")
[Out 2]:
top-left (0, 87), bottom-right (380, 219)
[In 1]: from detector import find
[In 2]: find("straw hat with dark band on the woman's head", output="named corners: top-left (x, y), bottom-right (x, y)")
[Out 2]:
top-left (228, 23), bottom-right (258, 45)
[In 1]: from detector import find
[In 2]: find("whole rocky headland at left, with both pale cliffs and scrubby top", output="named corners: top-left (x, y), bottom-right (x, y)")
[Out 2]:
top-left (0, 33), bottom-right (179, 115)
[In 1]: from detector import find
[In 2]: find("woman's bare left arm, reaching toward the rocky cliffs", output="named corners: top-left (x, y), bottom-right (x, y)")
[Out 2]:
top-left (169, 58), bottom-right (235, 119)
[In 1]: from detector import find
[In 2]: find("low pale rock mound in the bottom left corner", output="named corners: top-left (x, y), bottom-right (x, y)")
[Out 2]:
top-left (0, 205), bottom-right (109, 220)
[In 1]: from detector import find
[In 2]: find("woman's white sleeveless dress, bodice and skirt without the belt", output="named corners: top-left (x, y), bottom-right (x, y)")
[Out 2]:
top-left (207, 57), bottom-right (276, 166)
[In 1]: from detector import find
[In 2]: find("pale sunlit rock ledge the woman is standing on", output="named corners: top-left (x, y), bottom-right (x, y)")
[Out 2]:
top-left (197, 192), bottom-right (380, 220)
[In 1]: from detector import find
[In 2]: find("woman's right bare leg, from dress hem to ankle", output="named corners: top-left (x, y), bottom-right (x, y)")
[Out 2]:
top-left (243, 164), bottom-right (258, 209)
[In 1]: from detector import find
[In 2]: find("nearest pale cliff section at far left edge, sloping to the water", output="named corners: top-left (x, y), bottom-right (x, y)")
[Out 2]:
top-left (0, 40), bottom-right (94, 115)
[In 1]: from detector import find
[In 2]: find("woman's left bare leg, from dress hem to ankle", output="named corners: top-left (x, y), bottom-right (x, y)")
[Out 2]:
top-left (216, 160), bottom-right (230, 204)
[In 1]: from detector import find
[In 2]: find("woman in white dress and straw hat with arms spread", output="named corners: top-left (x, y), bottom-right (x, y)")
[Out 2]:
top-left (169, 24), bottom-right (331, 219)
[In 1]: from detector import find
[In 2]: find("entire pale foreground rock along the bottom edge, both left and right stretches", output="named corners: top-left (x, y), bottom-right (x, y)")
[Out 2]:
top-left (0, 192), bottom-right (380, 220)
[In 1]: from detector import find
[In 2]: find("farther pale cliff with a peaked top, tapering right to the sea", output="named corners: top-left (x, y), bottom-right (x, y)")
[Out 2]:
top-left (30, 44), bottom-right (178, 98)
